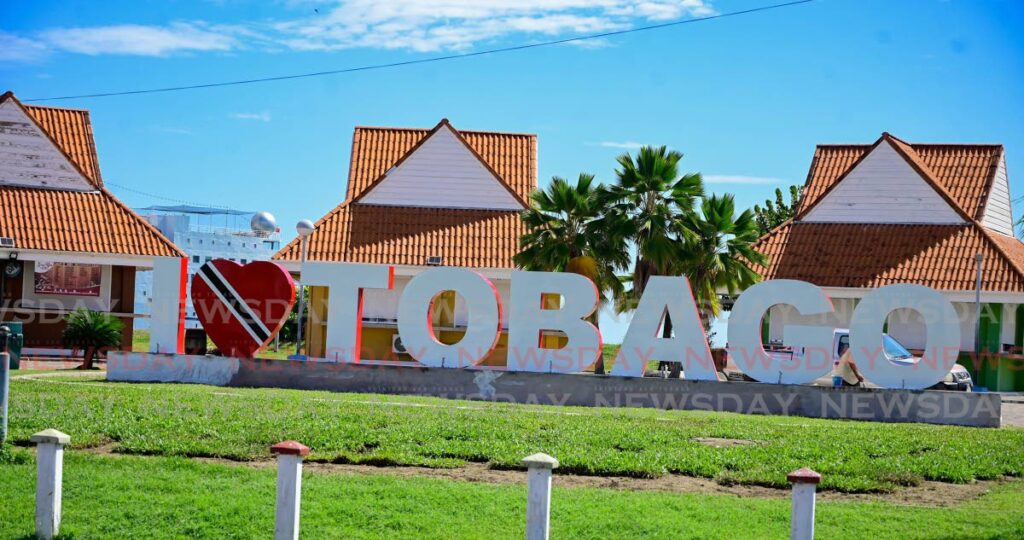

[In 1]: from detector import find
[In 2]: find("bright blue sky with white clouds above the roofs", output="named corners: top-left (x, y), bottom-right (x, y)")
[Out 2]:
top-left (0, 0), bottom-right (1024, 340)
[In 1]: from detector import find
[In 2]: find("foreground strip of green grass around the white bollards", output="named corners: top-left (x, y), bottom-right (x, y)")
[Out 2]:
top-left (0, 451), bottom-right (1024, 539)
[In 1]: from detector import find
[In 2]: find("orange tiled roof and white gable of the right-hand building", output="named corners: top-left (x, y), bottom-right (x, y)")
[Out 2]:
top-left (755, 133), bottom-right (1024, 293)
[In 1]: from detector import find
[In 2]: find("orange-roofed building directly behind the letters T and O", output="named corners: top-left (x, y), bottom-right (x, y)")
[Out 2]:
top-left (274, 119), bottom-right (537, 361)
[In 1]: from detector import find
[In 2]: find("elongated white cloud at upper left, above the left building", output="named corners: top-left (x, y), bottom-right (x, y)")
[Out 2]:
top-left (40, 23), bottom-right (239, 56)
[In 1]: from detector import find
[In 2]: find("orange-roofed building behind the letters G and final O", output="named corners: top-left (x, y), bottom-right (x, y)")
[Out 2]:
top-left (756, 133), bottom-right (1024, 389)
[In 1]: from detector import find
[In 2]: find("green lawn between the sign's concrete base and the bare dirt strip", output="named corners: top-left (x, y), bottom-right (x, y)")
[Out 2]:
top-left (10, 375), bottom-right (1024, 492)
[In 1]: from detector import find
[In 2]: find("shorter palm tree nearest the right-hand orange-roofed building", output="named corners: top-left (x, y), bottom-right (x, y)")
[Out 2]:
top-left (679, 195), bottom-right (766, 330)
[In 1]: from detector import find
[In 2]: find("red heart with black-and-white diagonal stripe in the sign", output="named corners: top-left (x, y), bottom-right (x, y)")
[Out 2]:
top-left (191, 259), bottom-right (295, 358)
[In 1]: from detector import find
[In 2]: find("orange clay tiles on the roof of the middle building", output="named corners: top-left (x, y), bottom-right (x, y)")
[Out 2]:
top-left (274, 121), bottom-right (537, 268)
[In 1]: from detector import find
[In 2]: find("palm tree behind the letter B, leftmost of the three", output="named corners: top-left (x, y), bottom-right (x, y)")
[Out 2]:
top-left (514, 173), bottom-right (629, 374)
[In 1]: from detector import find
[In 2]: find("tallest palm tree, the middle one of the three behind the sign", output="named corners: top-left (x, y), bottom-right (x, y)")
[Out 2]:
top-left (606, 147), bottom-right (703, 321)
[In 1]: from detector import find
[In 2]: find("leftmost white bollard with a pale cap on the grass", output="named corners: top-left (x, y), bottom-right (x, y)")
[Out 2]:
top-left (30, 429), bottom-right (71, 540)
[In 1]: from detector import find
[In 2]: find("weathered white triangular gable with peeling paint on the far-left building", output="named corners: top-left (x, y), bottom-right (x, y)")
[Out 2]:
top-left (0, 92), bottom-right (96, 192)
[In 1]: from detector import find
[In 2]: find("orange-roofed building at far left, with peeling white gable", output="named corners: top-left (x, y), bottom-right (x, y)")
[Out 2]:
top-left (0, 92), bottom-right (184, 352)
